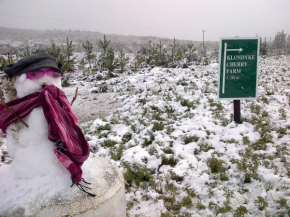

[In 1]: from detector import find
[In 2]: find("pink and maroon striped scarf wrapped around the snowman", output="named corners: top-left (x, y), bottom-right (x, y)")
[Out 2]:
top-left (0, 85), bottom-right (90, 183)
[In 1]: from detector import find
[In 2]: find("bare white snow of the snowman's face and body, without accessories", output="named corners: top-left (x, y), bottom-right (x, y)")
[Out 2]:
top-left (0, 74), bottom-right (79, 215)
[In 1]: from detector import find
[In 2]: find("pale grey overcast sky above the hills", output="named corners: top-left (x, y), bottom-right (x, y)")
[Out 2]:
top-left (0, 0), bottom-right (290, 41)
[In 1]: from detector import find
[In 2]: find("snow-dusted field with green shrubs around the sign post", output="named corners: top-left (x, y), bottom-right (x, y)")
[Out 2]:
top-left (0, 56), bottom-right (290, 217)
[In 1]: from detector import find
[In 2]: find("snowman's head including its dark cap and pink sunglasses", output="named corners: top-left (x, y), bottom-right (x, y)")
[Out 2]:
top-left (4, 51), bottom-right (62, 97)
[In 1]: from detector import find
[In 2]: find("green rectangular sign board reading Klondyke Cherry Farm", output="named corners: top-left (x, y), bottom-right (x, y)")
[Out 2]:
top-left (218, 38), bottom-right (259, 99)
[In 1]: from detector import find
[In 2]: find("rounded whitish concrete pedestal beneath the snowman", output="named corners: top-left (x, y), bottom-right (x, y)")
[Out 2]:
top-left (37, 157), bottom-right (126, 217)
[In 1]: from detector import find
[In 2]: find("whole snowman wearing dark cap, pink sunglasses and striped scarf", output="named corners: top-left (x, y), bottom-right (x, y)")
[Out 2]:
top-left (0, 52), bottom-right (122, 216)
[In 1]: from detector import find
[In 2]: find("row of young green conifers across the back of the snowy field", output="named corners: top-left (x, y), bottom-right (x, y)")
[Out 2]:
top-left (0, 31), bottom-right (290, 74)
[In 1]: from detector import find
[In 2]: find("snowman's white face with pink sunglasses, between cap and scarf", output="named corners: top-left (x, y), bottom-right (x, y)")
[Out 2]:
top-left (15, 68), bottom-right (61, 97)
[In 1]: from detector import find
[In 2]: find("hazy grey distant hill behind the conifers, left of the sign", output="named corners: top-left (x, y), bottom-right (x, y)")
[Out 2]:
top-left (0, 27), bottom-right (218, 54)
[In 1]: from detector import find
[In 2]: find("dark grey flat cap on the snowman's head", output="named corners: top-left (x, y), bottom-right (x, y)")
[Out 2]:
top-left (4, 51), bottom-right (62, 76)
